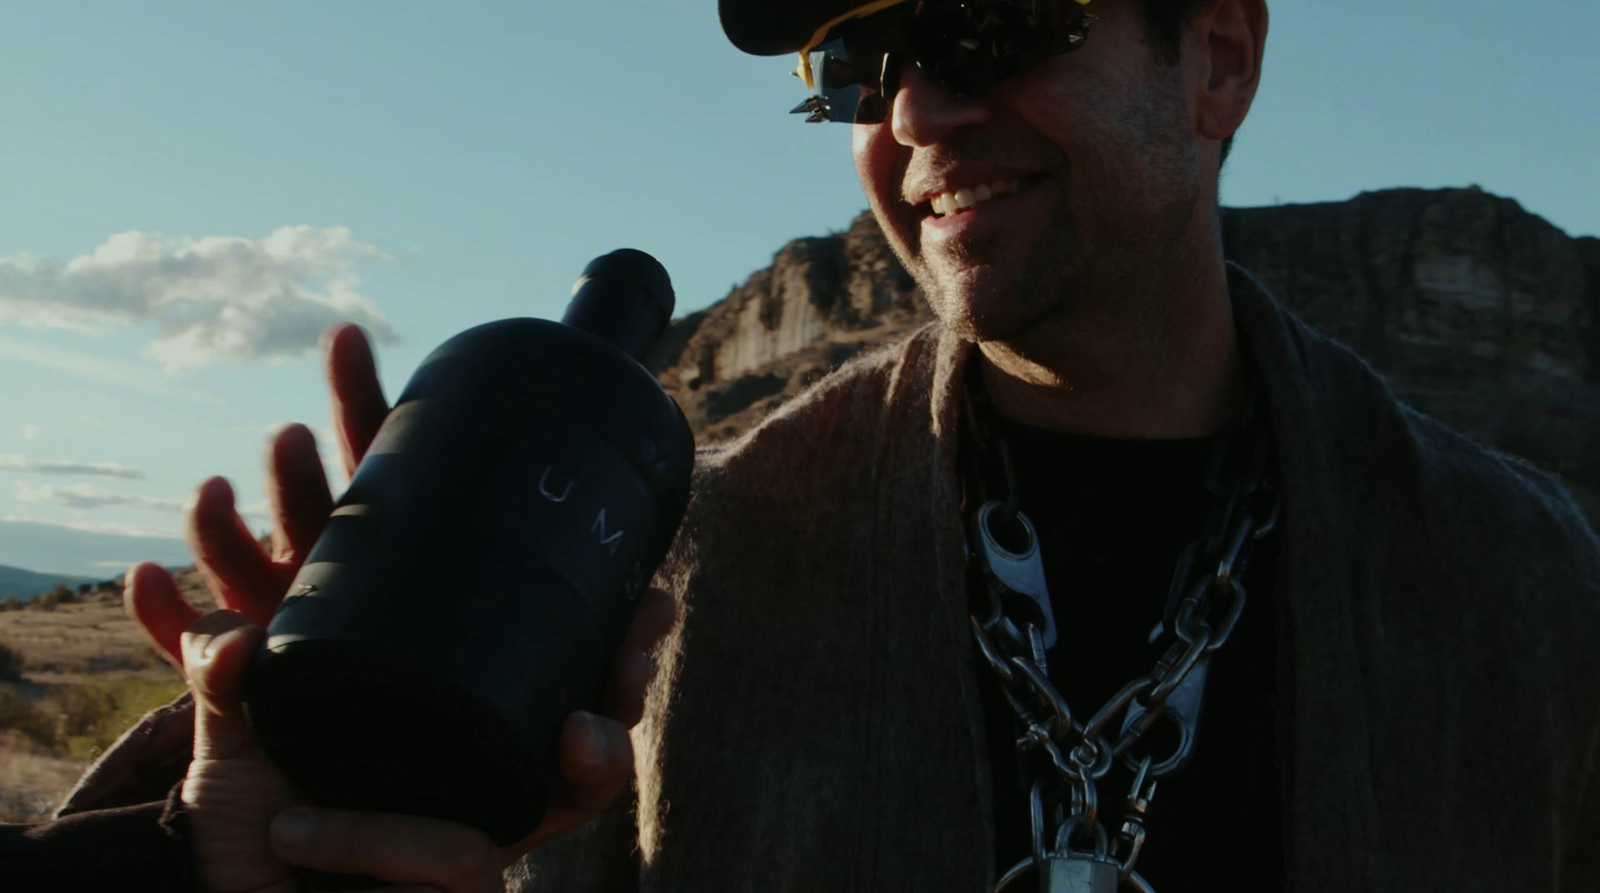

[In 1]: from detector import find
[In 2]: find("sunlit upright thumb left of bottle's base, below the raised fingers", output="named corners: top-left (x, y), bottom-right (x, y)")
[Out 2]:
top-left (182, 611), bottom-right (262, 760)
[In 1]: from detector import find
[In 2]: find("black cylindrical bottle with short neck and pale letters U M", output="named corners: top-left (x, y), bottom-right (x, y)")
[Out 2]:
top-left (243, 248), bottom-right (694, 845)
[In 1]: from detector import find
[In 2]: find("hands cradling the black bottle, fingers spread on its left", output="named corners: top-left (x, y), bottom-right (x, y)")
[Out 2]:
top-left (125, 326), bottom-right (677, 893)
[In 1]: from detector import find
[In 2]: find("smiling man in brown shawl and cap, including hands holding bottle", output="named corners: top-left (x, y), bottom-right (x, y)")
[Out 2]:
top-left (12, 0), bottom-right (1600, 893)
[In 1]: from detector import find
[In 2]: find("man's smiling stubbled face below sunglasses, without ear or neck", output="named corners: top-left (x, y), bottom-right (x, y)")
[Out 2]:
top-left (853, 0), bottom-right (1202, 341)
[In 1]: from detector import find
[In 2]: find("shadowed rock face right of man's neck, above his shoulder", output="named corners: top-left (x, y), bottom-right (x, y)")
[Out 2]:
top-left (1222, 189), bottom-right (1600, 519)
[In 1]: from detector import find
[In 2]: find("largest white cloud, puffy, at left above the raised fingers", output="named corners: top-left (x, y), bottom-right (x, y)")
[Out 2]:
top-left (0, 226), bottom-right (394, 371)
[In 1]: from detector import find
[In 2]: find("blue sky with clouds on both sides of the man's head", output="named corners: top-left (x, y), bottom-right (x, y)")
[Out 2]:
top-left (0, 0), bottom-right (1600, 575)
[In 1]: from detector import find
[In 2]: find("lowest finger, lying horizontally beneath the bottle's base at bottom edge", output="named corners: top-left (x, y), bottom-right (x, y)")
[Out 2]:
top-left (269, 807), bottom-right (502, 893)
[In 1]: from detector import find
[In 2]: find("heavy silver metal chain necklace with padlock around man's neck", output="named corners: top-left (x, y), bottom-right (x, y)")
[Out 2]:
top-left (963, 362), bottom-right (1280, 893)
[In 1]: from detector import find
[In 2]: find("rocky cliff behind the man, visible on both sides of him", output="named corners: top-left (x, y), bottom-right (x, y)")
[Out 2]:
top-left (656, 187), bottom-right (1600, 519)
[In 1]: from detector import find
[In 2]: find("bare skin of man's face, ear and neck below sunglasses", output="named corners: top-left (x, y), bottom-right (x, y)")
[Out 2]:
top-left (851, 0), bottom-right (1267, 437)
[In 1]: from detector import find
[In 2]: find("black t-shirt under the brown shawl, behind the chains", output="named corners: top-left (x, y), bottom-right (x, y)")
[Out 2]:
top-left (960, 419), bottom-right (1283, 891)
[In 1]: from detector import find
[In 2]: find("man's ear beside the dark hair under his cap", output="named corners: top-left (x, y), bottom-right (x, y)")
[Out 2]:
top-left (1184, 0), bottom-right (1267, 141)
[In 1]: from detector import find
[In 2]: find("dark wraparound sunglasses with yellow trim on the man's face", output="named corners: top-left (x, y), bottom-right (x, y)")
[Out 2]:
top-left (790, 0), bottom-right (1094, 123)
